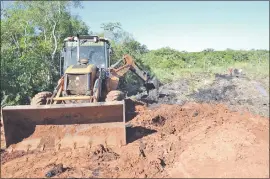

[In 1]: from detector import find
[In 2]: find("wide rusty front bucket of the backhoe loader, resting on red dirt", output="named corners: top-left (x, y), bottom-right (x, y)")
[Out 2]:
top-left (2, 101), bottom-right (126, 151)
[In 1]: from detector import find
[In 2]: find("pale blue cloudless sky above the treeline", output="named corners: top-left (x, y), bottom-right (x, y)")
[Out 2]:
top-left (71, 1), bottom-right (269, 52)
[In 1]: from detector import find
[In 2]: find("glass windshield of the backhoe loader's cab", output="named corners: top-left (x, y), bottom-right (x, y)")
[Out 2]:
top-left (64, 42), bottom-right (106, 70)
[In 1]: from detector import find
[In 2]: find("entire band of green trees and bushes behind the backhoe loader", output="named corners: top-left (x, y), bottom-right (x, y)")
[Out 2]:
top-left (0, 1), bottom-right (269, 105)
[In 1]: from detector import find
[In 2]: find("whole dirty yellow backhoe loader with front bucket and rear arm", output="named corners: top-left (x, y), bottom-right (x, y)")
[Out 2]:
top-left (2, 35), bottom-right (158, 151)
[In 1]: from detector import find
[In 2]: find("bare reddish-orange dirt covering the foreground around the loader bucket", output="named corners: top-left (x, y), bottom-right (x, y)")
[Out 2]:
top-left (1, 103), bottom-right (269, 178)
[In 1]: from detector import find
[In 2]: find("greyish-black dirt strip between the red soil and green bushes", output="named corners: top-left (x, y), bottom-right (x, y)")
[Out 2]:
top-left (137, 73), bottom-right (269, 117)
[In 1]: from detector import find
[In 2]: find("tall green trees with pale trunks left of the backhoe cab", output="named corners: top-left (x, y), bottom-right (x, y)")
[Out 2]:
top-left (1, 1), bottom-right (89, 104)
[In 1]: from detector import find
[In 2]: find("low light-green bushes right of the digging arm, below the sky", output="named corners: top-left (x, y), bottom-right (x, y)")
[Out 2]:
top-left (142, 48), bottom-right (269, 82)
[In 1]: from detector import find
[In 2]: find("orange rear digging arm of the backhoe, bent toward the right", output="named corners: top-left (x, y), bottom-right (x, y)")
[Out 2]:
top-left (110, 55), bottom-right (158, 92)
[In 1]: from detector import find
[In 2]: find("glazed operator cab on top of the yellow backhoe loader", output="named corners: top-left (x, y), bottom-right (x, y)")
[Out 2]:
top-left (60, 35), bottom-right (111, 75)
